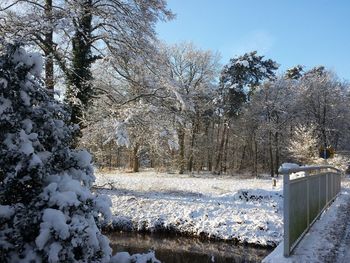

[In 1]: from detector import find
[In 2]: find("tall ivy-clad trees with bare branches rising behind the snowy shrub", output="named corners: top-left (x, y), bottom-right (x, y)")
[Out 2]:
top-left (0, 0), bottom-right (173, 128)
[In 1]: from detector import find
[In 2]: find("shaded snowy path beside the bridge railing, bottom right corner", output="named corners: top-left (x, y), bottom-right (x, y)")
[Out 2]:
top-left (263, 179), bottom-right (350, 263)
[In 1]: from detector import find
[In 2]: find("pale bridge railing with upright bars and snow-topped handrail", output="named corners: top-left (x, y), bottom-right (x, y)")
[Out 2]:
top-left (279, 165), bottom-right (341, 257)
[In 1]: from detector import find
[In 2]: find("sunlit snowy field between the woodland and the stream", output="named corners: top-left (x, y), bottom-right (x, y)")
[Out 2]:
top-left (95, 171), bottom-right (283, 246)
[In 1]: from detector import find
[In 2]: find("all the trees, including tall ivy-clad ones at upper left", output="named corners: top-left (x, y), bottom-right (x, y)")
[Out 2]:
top-left (0, 0), bottom-right (349, 176)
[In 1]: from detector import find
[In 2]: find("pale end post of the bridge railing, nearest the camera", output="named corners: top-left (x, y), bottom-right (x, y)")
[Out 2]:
top-left (283, 173), bottom-right (290, 257)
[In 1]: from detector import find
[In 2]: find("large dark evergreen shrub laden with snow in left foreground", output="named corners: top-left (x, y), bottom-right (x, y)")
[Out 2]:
top-left (0, 45), bottom-right (111, 262)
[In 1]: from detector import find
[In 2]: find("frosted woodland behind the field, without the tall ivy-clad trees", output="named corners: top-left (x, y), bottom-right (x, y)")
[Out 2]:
top-left (81, 43), bottom-right (350, 176)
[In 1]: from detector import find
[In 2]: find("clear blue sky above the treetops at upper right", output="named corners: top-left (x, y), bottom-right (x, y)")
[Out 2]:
top-left (157, 0), bottom-right (350, 80)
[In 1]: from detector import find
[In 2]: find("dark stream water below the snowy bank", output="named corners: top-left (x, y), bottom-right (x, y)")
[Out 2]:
top-left (107, 232), bottom-right (271, 263)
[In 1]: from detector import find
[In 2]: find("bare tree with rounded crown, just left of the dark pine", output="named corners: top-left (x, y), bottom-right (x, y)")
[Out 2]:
top-left (168, 43), bottom-right (219, 174)
